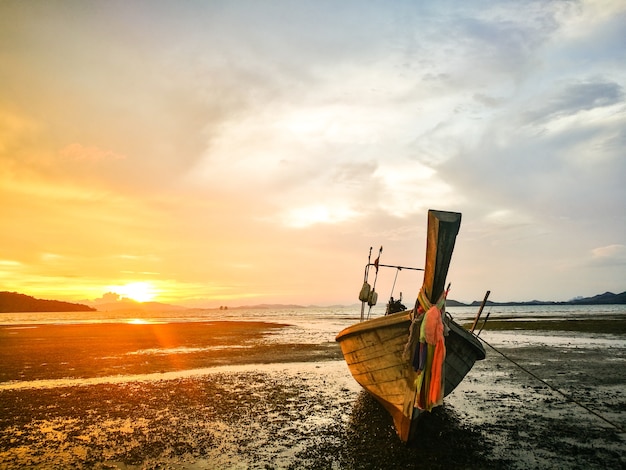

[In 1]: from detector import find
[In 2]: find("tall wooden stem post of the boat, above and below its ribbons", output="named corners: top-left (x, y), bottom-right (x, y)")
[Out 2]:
top-left (396, 209), bottom-right (461, 442)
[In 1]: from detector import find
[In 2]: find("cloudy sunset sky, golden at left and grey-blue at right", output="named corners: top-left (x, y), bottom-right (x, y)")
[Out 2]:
top-left (0, 0), bottom-right (626, 307)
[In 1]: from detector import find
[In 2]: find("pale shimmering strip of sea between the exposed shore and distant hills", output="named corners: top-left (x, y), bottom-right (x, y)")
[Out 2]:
top-left (0, 305), bottom-right (626, 347)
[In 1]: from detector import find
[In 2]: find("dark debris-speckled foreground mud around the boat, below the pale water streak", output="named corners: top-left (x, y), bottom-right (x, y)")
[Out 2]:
top-left (0, 320), bottom-right (626, 470)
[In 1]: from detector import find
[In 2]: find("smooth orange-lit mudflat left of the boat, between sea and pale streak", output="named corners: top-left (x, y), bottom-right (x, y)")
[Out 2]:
top-left (0, 321), bottom-right (341, 383)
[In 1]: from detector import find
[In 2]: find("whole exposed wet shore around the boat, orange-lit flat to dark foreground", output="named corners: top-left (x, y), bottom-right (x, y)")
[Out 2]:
top-left (0, 322), bottom-right (626, 469)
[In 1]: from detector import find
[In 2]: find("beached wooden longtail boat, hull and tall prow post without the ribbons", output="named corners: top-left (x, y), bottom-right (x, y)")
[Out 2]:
top-left (336, 210), bottom-right (485, 442)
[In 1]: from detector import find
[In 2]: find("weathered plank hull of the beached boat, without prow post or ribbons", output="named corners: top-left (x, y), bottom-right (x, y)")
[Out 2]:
top-left (336, 311), bottom-right (485, 441)
